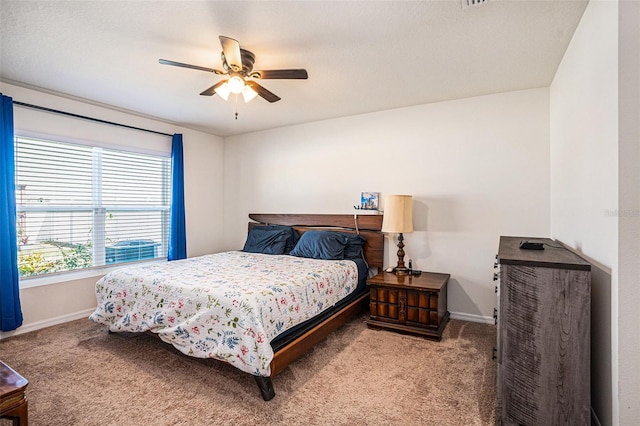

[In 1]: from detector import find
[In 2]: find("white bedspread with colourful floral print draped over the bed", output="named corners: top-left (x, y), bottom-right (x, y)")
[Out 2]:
top-left (89, 251), bottom-right (358, 376)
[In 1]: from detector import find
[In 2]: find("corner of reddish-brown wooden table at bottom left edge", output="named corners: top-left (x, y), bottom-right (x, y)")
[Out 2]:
top-left (0, 361), bottom-right (29, 426)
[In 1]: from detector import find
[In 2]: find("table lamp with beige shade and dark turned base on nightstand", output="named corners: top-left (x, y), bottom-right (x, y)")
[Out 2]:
top-left (382, 195), bottom-right (413, 275)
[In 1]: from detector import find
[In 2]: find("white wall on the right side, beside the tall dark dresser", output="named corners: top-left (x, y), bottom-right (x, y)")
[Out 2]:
top-left (550, 0), bottom-right (640, 425)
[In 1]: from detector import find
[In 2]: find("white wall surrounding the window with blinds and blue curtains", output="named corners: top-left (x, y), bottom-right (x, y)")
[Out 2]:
top-left (0, 82), bottom-right (223, 337)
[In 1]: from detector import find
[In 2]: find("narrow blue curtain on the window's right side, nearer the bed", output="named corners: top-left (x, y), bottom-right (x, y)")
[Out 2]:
top-left (168, 133), bottom-right (187, 260)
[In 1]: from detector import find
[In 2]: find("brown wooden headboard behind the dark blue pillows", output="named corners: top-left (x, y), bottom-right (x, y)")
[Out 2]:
top-left (249, 213), bottom-right (384, 269)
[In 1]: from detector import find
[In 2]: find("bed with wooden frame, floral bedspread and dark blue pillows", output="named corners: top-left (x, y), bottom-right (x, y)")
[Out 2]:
top-left (90, 214), bottom-right (384, 401)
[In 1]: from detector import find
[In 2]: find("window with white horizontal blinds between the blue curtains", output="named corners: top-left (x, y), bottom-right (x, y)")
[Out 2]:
top-left (15, 137), bottom-right (171, 277)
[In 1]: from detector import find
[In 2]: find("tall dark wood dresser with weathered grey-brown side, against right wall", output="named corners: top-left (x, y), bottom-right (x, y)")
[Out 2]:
top-left (496, 237), bottom-right (591, 426)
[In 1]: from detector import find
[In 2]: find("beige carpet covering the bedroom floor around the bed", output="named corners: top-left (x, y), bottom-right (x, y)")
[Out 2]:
top-left (0, 316), bottom-right (496, 426)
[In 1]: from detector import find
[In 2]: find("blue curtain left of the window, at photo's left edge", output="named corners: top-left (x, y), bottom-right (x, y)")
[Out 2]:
top-left (0, 93), bottom-right (22, 331)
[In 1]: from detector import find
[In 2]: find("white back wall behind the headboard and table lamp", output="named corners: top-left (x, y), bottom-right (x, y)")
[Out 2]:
top-left (224, 89), bottom-right (549, 322)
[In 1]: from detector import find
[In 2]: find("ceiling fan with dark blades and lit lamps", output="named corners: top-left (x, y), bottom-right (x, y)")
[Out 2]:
top-left (159, 36), bottom-right (309, 102)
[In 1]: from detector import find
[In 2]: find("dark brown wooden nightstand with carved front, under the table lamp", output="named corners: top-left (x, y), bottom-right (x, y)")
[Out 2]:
top-left (367, 272), bottom-right (450, 340)
